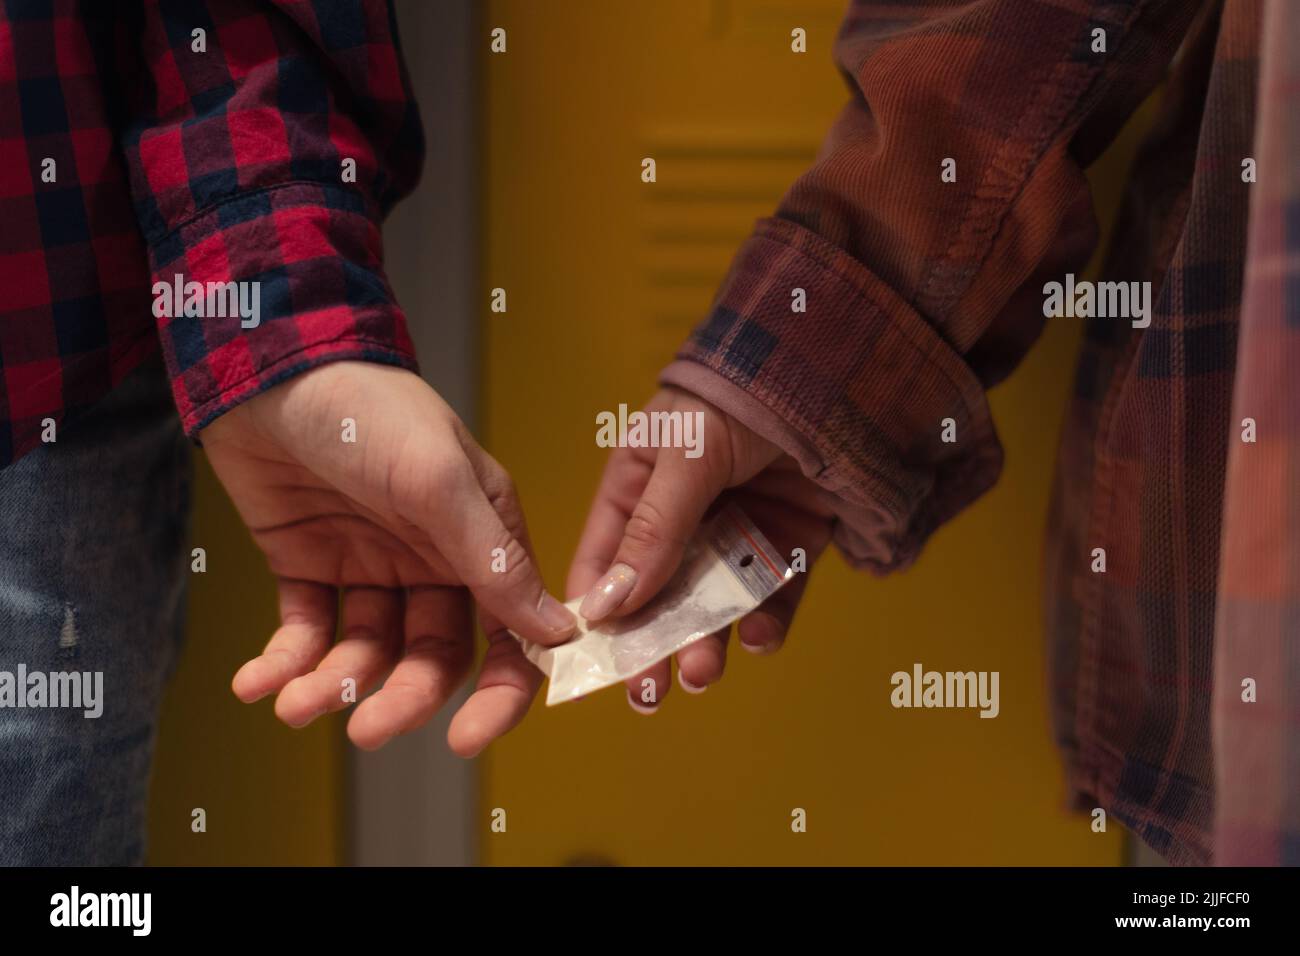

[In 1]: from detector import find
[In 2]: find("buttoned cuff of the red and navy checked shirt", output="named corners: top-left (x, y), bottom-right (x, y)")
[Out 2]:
top-left (150, 182), bottom-right (417, 437)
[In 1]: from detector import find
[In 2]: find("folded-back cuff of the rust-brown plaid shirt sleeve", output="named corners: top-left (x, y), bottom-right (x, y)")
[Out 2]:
top-left (660, 219), bottom-right (1002, 574)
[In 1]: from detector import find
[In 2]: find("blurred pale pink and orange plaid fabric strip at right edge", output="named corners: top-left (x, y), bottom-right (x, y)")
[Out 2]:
top-left (1213, 0), bottom-right (1300, 866)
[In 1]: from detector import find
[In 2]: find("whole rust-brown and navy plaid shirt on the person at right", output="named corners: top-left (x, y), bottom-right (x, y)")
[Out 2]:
top-left (663, 0), bottom-right (1300, 864)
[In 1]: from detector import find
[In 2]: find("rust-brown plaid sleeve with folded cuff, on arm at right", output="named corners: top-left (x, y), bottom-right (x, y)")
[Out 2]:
top-left (662, 0), bottom-right (1196, 572)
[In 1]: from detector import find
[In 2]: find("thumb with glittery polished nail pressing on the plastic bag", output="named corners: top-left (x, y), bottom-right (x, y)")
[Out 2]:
top-left (579, 447), bottom-right (731, 620)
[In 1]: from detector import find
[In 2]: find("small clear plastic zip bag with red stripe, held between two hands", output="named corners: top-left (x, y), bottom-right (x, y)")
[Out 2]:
top-left (515, 505), bottom-right (794, 706)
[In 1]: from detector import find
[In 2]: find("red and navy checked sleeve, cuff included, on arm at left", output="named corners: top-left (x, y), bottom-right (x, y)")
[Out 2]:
top-left (124, 0), bottom-right (423, 434)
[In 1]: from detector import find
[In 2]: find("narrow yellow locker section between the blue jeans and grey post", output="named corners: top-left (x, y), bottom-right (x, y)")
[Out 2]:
top-left (148, 451), bottom-right (346, 866)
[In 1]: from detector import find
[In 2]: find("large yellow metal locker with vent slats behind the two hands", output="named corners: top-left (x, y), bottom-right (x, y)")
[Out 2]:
top-left (481, 0), bottom-right (1149, 865)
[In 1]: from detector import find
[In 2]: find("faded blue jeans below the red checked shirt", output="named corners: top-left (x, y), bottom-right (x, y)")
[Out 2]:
top-left (0, 360), bottom-right (190, 866)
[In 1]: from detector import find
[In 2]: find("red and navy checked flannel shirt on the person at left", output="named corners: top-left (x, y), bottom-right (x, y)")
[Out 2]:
top-left (0, 0), bottom-right (423, 466)
